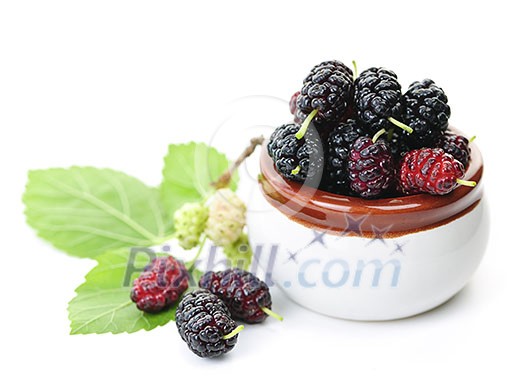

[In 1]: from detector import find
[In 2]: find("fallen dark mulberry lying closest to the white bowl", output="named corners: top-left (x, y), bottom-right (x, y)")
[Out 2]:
top-left (199, 268), bottom-right (272, 323)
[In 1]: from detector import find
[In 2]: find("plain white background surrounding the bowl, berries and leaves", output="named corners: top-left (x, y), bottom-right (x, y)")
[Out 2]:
top-left (0, 0), bottom-right (525, 383)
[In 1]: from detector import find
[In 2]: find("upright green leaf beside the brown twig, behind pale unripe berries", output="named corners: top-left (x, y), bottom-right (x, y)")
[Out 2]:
top-left (160, 143), bottom-right (238, 216)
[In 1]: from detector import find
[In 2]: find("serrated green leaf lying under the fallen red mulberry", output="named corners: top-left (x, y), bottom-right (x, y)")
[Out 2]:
top-left (68, 250), bottom-right (201, 334)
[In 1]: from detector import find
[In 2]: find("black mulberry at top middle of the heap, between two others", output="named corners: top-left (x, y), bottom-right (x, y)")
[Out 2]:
top-left (354, 68), bottom-right (402, 132)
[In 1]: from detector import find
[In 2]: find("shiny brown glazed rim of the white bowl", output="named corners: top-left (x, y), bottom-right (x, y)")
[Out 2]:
top-left (259, 130), bottom-right (483, 238)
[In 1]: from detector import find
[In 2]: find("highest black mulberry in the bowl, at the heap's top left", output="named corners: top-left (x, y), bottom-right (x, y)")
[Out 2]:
top-left (295, 60), bottom-right (354, 130)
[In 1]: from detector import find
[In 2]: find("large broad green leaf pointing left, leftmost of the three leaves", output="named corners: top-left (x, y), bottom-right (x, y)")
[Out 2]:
top-left (23, 167), bottom-right (173, 257)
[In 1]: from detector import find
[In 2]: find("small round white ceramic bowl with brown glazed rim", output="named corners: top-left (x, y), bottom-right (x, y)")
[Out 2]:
top-left (248, 136), bottom-right (489, 320)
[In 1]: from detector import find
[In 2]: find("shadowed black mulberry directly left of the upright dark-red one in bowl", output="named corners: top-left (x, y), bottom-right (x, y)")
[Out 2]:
top-left (322, 120), bottom-right (366, 195)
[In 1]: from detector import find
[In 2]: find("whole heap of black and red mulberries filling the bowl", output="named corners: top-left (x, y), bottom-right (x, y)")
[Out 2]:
top-left (268, 61), bottom-right (476, 199)
